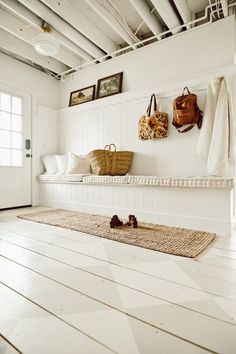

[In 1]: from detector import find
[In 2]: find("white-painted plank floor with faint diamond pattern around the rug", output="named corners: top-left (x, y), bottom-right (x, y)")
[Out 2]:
top-left (0, 208), bottom-right (236, 354)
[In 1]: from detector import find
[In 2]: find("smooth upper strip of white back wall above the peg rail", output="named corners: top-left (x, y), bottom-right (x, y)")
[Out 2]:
top-left (60, 16), bottom-right (236, 108)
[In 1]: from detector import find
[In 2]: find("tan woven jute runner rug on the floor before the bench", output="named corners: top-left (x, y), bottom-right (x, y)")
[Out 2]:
top-left (18, 209), bottom-right (215, 258)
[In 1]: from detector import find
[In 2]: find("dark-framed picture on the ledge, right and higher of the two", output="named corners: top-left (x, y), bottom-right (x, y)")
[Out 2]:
top-left (96, 73), bottom-right (123, 98)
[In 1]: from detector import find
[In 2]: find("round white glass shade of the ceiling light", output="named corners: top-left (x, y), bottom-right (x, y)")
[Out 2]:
top-left (33, 32), bottom-right (60, 56)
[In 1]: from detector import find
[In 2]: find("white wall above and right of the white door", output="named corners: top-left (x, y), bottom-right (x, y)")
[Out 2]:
top-left (0, 54), bottom-right (59, 205)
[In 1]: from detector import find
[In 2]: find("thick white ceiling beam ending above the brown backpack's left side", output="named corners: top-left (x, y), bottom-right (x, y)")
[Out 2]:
top-left (151, 0), bottom-right (181, 34)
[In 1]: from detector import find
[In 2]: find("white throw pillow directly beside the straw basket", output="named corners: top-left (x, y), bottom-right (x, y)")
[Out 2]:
top-left (66, 152), bottom-right (90, 175)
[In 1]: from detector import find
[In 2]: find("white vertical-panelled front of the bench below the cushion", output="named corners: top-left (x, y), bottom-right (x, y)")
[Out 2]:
top-left (40, 182), bottom-right (234, 236)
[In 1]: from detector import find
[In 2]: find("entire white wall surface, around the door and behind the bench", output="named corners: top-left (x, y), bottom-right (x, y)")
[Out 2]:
top-left (0, 17), bottom-right (235, 209)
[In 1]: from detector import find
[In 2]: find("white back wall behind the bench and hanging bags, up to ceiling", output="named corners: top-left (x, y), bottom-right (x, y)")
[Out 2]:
top-left (59, 17), bottom-right (235, 176)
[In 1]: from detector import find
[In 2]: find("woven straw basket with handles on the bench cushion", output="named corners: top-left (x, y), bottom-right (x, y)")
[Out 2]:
top-left (89, 144), bottom-right (133, 176)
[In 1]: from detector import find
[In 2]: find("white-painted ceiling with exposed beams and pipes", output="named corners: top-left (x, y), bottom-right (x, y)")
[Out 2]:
top-left (0, 0), bottom-right (227, 79)
